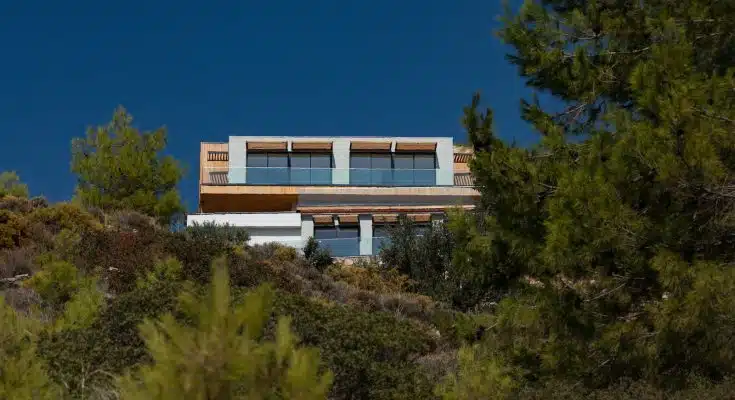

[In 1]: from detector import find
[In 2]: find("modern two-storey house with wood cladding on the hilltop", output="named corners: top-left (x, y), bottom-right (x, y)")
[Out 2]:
top-left (187, 136), bottom-right (479, 256)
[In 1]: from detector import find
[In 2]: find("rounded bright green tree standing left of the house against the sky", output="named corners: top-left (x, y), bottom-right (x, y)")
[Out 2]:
top-left (72, 107), bottom-right (183, 223)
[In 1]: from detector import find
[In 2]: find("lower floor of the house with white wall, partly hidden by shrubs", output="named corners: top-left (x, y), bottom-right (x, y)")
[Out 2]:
top-left (187, 212), bottom-right (444, 257)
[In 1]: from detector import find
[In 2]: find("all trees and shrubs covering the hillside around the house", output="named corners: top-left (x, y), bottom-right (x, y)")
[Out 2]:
top-left (0, 0), bottom-right (735, 400)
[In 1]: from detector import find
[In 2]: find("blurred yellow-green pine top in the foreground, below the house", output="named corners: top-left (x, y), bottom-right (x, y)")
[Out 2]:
top-left (121, 258), bottom-right (331, 399)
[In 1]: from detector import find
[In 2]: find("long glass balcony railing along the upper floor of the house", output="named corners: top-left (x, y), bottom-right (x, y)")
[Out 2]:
top-left (202, 167), bottom-right (436, 186)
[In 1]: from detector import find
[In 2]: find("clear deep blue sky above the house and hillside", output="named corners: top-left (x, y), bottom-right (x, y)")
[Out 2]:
top-left (0, 0), bottom-right (535, 211)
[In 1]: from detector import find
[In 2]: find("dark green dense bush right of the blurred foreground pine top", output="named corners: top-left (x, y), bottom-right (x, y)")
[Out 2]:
top-left (275, 293), bottom-right (435, 399)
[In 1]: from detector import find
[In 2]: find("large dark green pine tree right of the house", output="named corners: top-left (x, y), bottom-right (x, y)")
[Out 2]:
top-left (455, 0), bottom-right (735, 385)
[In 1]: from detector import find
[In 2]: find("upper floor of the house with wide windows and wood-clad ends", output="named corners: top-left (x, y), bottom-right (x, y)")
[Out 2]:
top-left (199, 136), bottom-right (472, 187)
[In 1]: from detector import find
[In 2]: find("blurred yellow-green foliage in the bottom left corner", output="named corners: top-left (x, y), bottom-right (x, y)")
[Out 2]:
top-left (0, 296), bottom-right (61, 400)
